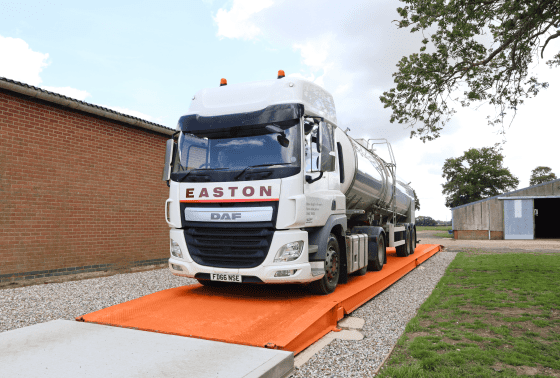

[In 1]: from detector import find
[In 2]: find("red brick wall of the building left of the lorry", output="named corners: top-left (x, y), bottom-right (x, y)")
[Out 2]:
top-left (0, 90), bottom-right (169, 284)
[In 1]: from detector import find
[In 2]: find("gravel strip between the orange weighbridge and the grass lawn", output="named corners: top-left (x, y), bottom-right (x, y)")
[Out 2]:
top-left (290, 252), bottom-right (456, 378)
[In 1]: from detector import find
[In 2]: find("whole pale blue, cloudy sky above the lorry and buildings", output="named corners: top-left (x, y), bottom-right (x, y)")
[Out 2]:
top-left (0, 0), bottom-right (560, 220)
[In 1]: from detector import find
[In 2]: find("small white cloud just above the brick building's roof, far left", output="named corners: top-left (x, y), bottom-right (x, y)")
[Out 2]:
top-left (0, 36), bottom-right (49, 86)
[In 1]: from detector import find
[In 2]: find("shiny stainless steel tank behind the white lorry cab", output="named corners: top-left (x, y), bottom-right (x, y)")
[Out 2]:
top-left (336, 128), bottom-right (414, 216)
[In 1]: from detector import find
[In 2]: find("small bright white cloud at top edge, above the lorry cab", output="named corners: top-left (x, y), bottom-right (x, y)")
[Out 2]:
top-left (213, 0), bottom-right (273, 39)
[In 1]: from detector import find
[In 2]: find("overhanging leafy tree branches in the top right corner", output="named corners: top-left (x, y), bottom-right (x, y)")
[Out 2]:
top-left (380, 0), bottom-right (560, 142)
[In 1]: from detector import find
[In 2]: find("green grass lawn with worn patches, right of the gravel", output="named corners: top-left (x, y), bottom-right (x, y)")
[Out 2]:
top-left (378, 252), bottom-right (560, 378)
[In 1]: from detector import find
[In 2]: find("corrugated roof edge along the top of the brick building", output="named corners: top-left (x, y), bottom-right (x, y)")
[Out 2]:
top-left (0, 77), bottom-right (175, 135)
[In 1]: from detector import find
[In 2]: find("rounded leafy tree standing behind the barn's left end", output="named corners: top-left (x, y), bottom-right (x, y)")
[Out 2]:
top-left (442, 144), bottom-right (519, 207)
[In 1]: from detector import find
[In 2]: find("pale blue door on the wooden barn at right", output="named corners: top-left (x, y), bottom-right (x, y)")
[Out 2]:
top-left (504, 199), bottom-right (535, 239)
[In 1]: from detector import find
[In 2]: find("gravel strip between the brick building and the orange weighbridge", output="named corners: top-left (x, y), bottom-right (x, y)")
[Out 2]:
top-left (0, 269), bottom-right (196, 332)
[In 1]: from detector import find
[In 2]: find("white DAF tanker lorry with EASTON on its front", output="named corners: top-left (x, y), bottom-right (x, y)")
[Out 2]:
top-left (163, 71), bottom-right (416, 294)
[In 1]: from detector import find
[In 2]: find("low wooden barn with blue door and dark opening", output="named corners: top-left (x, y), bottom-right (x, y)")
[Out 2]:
top-left (451, 179), bottom-right (560, 239)
